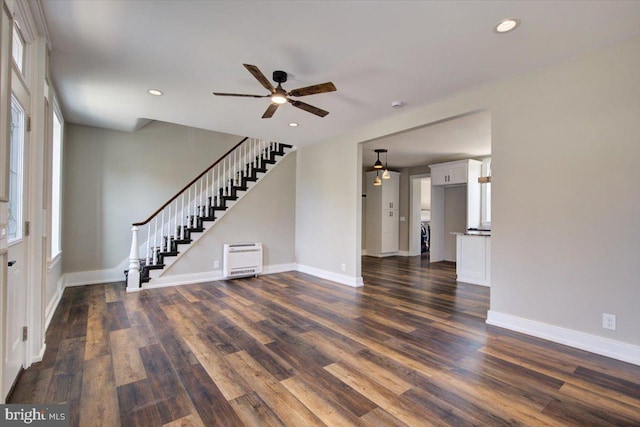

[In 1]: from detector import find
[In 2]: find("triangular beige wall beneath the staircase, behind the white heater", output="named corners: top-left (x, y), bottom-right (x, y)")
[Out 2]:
top-left (163, 152), bottom-right (296, 277)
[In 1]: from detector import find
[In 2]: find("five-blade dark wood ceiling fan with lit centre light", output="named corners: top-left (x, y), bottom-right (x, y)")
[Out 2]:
top-left (213, 64), bottom-right (336, 119)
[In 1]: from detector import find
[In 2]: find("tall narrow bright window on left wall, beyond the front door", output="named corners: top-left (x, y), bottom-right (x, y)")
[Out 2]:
top-left (51, 104), bottom-right (64, 258)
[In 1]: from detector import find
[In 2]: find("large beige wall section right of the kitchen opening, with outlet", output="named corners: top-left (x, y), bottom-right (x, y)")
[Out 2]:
top-left (491, 38), bottom-right (640, 345)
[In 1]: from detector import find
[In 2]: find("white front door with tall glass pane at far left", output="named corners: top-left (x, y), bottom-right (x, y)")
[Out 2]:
top-left (3, 80), bottom-right (29, 393)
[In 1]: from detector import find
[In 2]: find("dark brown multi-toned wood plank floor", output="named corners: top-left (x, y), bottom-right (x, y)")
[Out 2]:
top-left (10, 257), bottom-right (640, 427)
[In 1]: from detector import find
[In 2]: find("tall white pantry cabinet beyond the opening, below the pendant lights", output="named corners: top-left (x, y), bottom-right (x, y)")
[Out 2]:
top-left (365, 171), bottom-right (400, 257)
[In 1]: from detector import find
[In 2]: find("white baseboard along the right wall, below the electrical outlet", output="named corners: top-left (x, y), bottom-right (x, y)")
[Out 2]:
top-left (487, 310), bottom-right (640, 365)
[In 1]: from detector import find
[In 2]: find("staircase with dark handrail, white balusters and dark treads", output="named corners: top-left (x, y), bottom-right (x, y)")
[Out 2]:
top-left (125, 138), bottom-right (293, 291)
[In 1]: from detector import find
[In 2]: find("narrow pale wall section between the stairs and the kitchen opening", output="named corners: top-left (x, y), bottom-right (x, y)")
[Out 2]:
top-left (296, 137), bottom-right (362, 283)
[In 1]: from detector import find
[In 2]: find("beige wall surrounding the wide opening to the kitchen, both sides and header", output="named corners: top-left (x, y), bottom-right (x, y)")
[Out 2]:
top-left (296, 38), bottom-right (640, 363)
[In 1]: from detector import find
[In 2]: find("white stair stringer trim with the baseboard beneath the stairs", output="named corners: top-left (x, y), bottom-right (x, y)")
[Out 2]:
top-left (142, 147), bottom-right (295, 289)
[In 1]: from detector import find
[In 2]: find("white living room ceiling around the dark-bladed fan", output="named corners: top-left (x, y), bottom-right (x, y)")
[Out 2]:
top-left (41, 0), bottom-right (640, 152)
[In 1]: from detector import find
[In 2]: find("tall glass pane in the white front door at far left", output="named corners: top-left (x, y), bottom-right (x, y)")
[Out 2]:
top-left (7, 96), bottom-right (25, 243)
